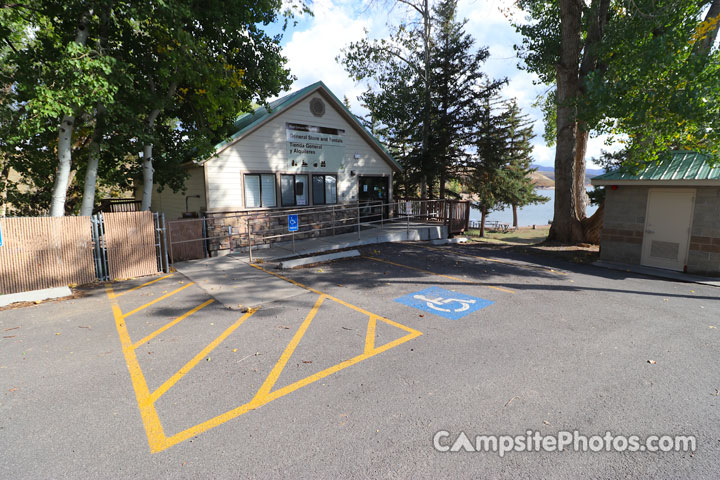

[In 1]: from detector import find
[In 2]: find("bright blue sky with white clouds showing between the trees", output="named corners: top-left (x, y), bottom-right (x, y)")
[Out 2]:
top-left (273, 0), bottom-right (611, 168)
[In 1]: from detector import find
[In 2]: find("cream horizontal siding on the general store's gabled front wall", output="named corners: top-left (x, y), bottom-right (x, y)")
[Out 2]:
top-left (205, 92), bottom-right (392, 211)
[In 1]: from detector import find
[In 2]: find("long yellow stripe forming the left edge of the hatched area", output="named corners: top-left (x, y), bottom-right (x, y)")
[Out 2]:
top-left (106, 286), bottom-right (167, 453)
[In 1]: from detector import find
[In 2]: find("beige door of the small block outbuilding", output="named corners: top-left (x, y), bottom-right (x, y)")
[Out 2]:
top-left (641, 189), bottom-right (695, 271)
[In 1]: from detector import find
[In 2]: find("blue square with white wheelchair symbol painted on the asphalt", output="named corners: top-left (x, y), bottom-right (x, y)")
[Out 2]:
top-left (395, 287), bottom-right (495, 320)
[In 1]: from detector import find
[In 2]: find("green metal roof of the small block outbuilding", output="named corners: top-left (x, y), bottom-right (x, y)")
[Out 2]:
top-left (592, 151), bottom-right (720, 184)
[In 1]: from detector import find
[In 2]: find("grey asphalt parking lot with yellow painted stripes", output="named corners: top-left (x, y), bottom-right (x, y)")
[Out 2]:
top-left (0, 244), bottom-right (720, 478)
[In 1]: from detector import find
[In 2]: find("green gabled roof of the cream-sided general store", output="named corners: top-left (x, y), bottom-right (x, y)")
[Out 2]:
top-left (210, 82), bottom-right (402, 171)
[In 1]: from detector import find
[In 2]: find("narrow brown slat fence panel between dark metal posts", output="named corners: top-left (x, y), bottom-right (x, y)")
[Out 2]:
top-left (103, 212), bottom-right (158, 280)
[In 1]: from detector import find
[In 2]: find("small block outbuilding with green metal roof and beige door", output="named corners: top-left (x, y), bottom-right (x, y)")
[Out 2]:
top-left (591, 151), bottom-right (720, 276)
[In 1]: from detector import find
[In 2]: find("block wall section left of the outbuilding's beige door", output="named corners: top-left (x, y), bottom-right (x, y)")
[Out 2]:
top-left (600, 186), bottom-right (648, 264)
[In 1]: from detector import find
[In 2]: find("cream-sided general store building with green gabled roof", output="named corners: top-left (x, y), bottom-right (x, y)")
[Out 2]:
top-left (152, 82), bottom-right (401, 220)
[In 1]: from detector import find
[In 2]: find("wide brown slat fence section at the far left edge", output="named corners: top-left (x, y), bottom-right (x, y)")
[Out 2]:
top-left (0, 217), bottom-right (95, 294)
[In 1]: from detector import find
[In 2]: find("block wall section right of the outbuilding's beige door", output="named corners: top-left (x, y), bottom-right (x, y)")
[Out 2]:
top-left (687, 187), bottom-right (720, 276)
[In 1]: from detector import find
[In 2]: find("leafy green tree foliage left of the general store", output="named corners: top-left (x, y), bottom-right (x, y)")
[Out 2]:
top-left (0, 0), bottom-right (300, 213)
